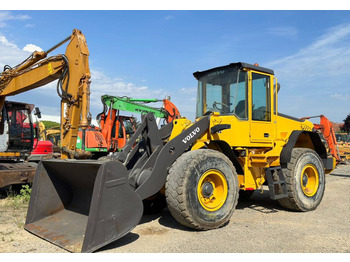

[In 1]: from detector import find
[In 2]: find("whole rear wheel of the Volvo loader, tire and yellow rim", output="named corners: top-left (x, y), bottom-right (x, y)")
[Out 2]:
top-left (278, 148), bottom-right (326, 211)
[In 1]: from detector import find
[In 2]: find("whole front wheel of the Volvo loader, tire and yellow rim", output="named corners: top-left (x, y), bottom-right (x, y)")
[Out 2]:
top-left (165, 149), bottom-right (238, 230)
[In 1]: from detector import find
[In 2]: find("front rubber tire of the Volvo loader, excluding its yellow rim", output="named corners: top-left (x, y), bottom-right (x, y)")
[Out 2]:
top-left (165, 149), bottom-right (239, 230)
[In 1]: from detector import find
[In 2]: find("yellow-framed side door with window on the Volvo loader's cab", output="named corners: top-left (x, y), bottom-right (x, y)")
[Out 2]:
top-left (249, 71), bottom-right (275, 143)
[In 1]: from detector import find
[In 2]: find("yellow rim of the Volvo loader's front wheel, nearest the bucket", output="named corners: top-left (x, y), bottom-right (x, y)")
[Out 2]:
top-left (197, 169), bottom-right (228, 211)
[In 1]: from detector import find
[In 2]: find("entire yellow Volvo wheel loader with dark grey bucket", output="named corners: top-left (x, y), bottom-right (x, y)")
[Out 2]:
top-left (25, 62), bottom-right (336, 252)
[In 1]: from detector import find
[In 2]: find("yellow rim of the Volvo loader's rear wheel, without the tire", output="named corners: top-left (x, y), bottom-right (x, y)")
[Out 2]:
top-left (300, 164), bottom-right (319, 197)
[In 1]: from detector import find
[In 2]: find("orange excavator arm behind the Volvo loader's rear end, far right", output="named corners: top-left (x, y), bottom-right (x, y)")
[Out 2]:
top-left (302, 115), bottom-right (350, 164)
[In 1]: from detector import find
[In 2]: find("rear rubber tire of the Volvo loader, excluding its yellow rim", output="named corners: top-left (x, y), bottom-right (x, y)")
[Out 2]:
top-left (278, 148), bottom-right (326, 211)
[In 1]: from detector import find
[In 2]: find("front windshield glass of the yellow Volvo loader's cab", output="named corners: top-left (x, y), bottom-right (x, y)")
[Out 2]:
top-left (196, 68), bottom-right (248, 119)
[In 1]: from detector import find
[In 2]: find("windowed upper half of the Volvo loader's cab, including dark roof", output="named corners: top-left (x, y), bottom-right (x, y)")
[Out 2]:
top-left (193, 63), bottom-right (277, 121)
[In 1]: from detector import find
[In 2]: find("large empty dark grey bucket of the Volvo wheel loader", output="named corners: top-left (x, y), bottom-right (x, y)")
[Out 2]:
top-left (24, 159), bottom-right (143, 252)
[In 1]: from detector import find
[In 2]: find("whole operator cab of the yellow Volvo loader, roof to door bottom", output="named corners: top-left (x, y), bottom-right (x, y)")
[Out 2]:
top-left (193, 62), bottom-right (278, 143)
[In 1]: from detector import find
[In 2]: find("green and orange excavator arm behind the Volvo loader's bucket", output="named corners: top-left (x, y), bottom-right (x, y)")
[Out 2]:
top-left (96, 95), bottom-right (181, 152)
